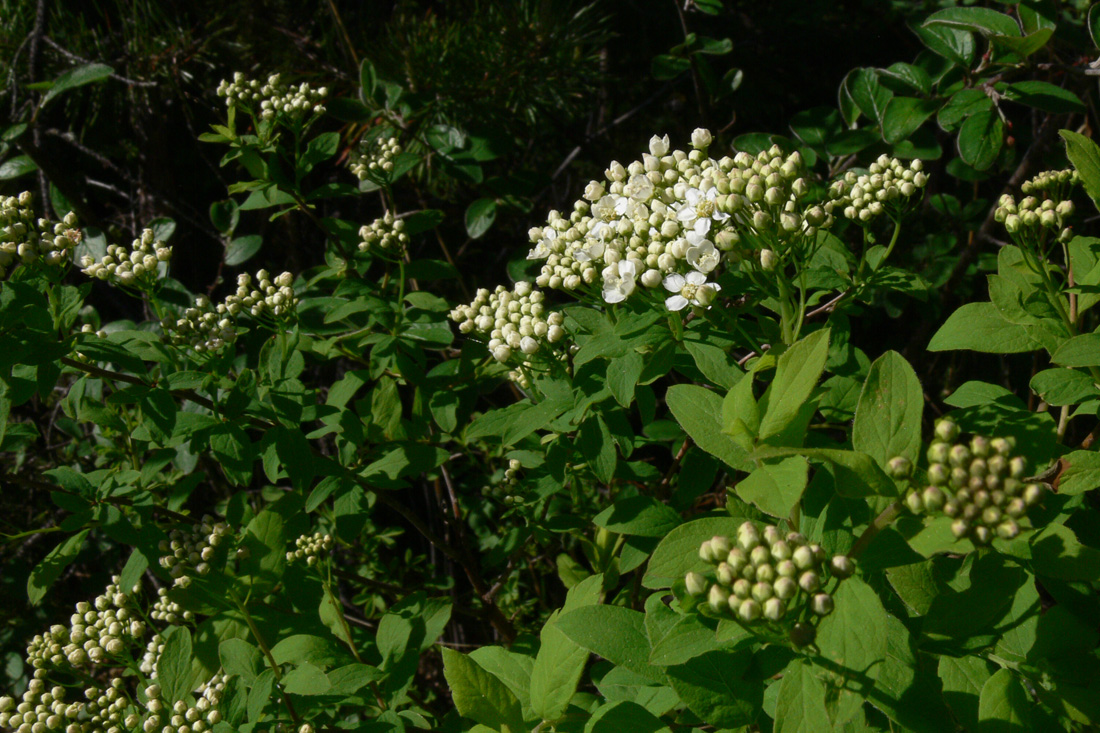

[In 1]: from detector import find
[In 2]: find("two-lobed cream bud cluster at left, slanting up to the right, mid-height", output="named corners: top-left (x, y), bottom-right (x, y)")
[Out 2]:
top-left (161, 270), bottom-right (298, 352)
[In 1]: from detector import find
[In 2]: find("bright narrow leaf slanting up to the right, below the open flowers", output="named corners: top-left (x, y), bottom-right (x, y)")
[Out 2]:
top-left (761, 328), bottom-right (829, 440)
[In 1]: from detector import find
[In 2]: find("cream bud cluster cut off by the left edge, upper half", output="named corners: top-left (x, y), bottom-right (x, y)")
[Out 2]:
top-left (0, 192), bottom-right (84, 280)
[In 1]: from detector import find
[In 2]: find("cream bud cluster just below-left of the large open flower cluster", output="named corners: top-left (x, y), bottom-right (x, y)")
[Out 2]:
top-left (451, 282), bottom-right (565, 361)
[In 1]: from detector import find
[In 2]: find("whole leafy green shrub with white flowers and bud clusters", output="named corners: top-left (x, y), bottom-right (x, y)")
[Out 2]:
top-left (0, 3), bottom-right (1100, 733)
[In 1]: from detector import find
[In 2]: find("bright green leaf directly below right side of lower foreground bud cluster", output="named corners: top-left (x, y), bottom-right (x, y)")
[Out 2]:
top-left (817, 578), bottom-right (887, 679)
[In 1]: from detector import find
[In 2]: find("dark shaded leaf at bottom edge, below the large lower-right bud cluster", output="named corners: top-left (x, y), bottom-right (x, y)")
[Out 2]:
top-left (667, 649), bottom-right (763, 729)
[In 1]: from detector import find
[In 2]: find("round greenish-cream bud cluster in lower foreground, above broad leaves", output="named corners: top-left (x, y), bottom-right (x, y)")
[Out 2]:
top-left (684, 522), bottom-right (855, 643)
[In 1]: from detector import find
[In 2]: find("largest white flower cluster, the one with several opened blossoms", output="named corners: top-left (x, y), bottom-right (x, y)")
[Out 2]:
top-left (527, 130), bottom-right (827, 310)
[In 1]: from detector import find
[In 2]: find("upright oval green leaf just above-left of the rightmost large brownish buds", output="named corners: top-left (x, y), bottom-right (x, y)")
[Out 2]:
top-left (851, 351), bottom-right (924, 467)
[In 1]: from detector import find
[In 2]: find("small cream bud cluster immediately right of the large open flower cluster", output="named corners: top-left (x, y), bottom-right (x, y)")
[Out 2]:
top-left (825, 155), bottom-right (928, 222)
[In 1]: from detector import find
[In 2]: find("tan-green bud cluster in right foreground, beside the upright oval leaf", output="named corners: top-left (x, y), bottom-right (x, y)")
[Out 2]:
top-left (905, 420), bottom-right (1044, 545)
